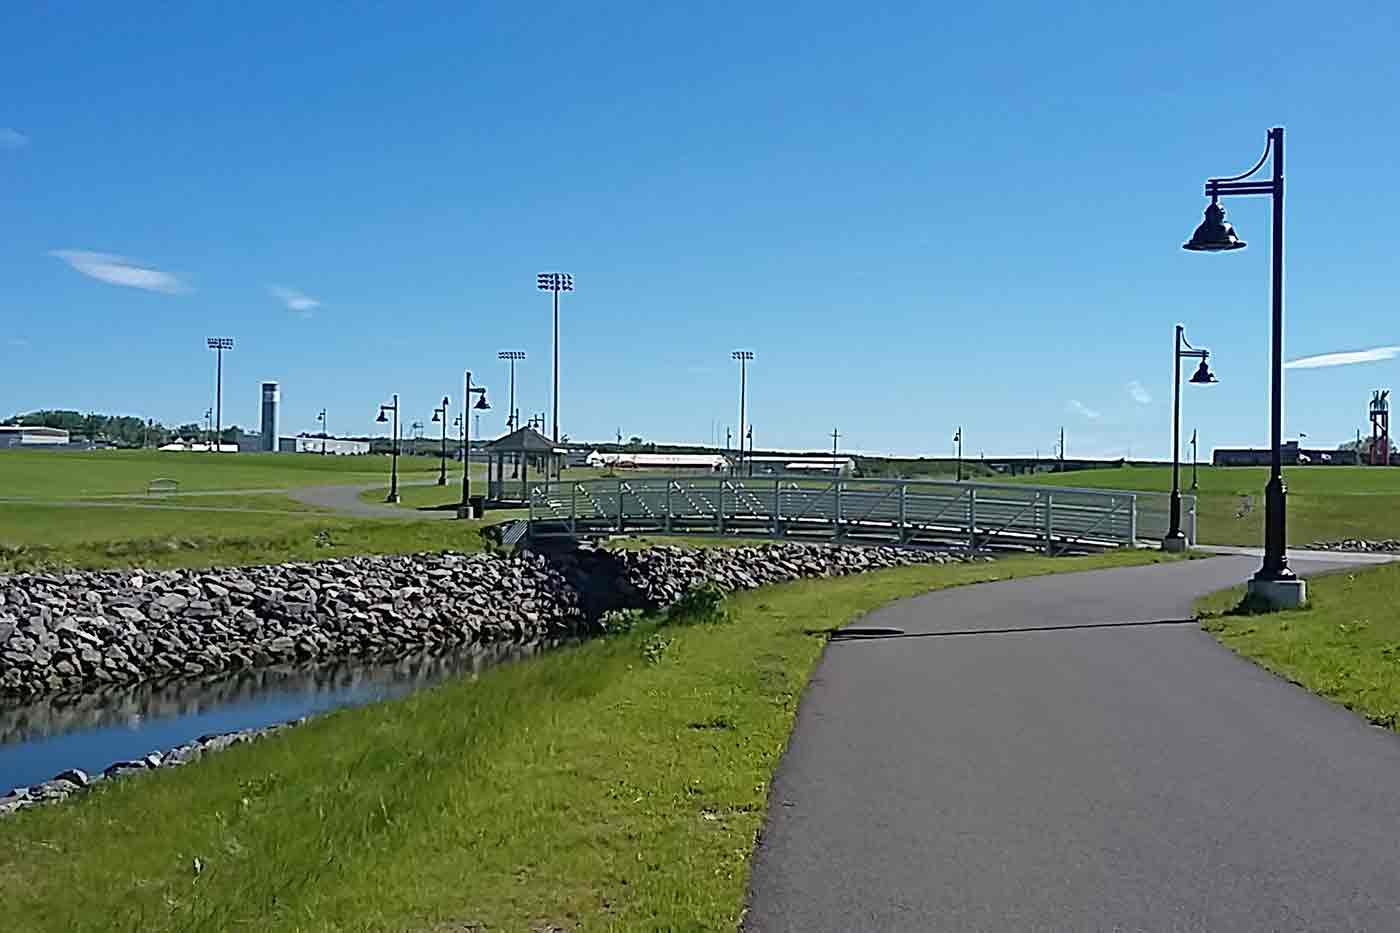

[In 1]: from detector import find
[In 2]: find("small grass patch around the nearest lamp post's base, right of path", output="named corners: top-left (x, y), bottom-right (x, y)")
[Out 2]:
top-left (1198, 565), bottom-right (1400, 728)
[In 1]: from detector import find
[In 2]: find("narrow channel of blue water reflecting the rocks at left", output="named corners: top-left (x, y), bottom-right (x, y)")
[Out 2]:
top-left (0, 642), bottom-right (559, 796)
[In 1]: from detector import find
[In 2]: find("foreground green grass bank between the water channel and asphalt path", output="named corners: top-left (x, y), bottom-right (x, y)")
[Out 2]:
top-left (0, 552), bottom-right (1162, 933)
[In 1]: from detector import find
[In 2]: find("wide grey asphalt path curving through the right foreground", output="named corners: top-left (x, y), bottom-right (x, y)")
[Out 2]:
top-left (745, 555), bottom-right (1400, 932)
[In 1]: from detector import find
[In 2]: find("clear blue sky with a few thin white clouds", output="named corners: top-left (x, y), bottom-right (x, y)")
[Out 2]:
top-left (0, 1), bottom-right (1400, 457)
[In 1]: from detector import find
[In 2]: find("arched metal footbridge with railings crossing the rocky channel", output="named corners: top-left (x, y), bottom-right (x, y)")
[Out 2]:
top-left (526, 476), bottom-right (1196, 553)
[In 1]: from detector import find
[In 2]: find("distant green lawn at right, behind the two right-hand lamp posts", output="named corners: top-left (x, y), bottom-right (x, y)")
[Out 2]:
top-left (1008, 467), bottom-right (1400, 548)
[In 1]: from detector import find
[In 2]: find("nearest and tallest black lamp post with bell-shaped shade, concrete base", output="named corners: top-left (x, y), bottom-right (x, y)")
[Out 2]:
top-left (1183, 126), bottom-right (1308, 609)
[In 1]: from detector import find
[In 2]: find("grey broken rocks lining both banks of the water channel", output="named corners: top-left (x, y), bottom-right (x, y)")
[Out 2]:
top-left (0, 544), bottom-right (974, 817)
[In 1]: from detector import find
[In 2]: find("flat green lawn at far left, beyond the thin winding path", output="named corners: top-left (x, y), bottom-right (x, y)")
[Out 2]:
top-left (0, 450), bottom-right (437, 499)
